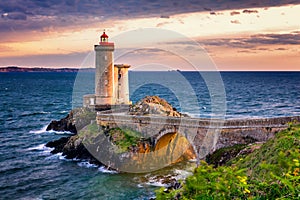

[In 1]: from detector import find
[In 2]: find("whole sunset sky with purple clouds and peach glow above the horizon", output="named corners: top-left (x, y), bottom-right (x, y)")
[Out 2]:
top-left (0, 0), bottom-right (300, 71)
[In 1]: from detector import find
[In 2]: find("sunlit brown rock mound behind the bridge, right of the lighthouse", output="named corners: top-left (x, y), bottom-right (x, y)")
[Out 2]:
top-left (128, 96), bottom-right (187, 117)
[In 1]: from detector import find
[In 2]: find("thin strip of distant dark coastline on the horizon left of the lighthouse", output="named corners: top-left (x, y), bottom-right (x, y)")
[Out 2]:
top-left (0, 66), bottom-right (95, 73)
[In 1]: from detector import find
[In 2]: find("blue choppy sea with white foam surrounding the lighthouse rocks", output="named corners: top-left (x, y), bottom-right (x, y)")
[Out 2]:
top-left (0, 71), bottom-right (300, 200)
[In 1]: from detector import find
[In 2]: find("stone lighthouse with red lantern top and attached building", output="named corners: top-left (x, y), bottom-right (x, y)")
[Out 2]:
top-left (83, 31), bottom-right (131, 110)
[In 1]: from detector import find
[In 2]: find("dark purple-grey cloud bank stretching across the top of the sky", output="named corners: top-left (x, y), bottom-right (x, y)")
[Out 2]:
top-left (0, 0), bottom-right (299, 32)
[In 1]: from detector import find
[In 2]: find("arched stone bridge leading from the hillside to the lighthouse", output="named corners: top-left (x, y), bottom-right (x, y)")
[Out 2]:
top-left (97, 112), bottom-right (300, 162)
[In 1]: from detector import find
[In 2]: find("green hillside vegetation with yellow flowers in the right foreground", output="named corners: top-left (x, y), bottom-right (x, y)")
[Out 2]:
top-left (157, 124), bottom-right (300, 200)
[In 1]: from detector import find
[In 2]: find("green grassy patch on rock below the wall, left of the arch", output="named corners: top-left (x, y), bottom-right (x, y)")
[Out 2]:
top-left (108, 128), bottom-right (141, 153)
